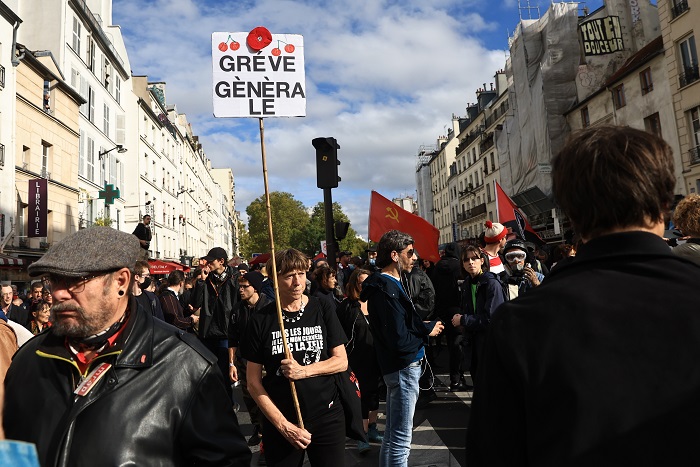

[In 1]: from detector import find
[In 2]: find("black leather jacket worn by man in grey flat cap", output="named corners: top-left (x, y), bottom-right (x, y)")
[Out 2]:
top-left (3, 298), bottom-right (251, 467)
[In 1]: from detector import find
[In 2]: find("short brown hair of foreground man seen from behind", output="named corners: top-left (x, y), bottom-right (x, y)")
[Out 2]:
top-left (552, 125), bottom-right (676, 238)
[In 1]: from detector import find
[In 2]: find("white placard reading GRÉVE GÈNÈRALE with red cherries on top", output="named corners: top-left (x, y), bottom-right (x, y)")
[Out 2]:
top-left (211, 27), bottom-right (306, 118)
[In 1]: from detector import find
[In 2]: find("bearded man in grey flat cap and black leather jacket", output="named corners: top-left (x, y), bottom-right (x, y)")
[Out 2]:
top-left (3, 227), bottom-right (251, 466)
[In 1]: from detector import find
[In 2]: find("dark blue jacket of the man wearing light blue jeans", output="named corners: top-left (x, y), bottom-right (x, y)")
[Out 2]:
top-left (360, 273), bottom-right (435, 375)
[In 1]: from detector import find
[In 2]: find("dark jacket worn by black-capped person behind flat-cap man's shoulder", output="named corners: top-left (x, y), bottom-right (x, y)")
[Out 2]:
top-left (199, 266), bottom-right (240, 339)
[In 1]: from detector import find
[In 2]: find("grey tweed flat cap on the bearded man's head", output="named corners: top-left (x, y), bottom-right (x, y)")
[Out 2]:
top-left (27, 227), bottom-right (141, 277)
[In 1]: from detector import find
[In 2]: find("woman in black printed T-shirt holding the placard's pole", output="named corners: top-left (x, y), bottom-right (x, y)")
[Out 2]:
top-left (241, 249), bottom-right (348, 466)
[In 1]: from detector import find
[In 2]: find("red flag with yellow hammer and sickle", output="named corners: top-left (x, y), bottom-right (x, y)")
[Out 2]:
top-left (369, 191), bottom-right (440, 263)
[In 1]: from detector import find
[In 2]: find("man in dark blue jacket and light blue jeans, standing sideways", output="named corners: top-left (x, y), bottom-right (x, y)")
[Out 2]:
top-left (360, 230), bottom-right (444, 467)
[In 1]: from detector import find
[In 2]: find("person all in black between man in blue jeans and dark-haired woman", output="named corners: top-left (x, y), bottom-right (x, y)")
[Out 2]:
top-left (431, 242), bottom-right (470, 391)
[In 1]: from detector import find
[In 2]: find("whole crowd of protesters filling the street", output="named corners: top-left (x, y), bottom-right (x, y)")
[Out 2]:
top-left (0, 127), bottom-right (700, 467)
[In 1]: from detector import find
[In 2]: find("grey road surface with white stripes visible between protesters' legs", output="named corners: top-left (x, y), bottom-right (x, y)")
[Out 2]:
top-left (234, 348), bottom-right (472, 467)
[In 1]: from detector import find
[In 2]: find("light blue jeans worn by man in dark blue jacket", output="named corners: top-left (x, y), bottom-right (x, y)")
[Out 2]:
top-left (379, 361), bottom-right (421, 467)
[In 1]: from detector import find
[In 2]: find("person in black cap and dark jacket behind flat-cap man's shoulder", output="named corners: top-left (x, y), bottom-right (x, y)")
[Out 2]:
top-left (199, 247), bottom-right (240, 397)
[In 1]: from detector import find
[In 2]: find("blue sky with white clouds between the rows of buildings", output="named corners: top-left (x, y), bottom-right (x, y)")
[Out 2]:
top-left (113, 0), bottom-right (602, 237)
